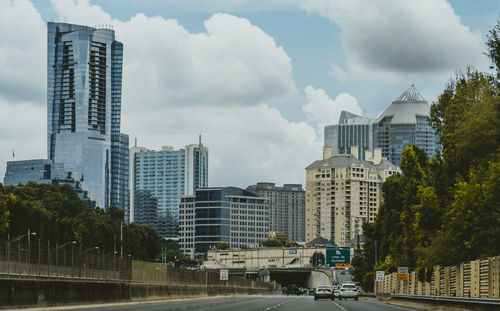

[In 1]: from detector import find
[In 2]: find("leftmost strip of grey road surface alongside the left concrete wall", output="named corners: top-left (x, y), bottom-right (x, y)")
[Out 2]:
top-left (67, 295), bottom-right (297, 311)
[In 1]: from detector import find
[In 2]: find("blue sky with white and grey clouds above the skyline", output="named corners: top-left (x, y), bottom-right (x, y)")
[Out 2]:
top-left (0, 0), bottom-right (500, 188)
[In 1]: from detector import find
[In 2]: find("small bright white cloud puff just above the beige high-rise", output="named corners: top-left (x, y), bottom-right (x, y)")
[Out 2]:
top-left (303, 86), bottom-right (361, 139)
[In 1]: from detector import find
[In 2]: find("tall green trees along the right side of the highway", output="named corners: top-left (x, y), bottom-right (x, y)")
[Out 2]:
top-left (353, 18), bottom-right (500, 289)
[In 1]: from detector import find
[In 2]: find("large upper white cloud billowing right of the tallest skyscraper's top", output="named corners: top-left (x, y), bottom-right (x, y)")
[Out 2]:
top-left (52, 0), bottom-right (296, 109)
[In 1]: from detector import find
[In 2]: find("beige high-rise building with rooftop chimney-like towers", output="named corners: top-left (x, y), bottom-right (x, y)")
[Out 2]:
top-left (306, 146), bottom-right (401, 246)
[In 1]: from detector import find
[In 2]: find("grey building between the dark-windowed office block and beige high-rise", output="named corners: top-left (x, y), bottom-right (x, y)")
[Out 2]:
top-left (247, 182), bottom-right (306, 242)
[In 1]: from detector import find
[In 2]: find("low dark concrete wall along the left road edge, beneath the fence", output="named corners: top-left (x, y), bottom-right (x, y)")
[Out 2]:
top-left (0, 279), bottom-right (275, 308)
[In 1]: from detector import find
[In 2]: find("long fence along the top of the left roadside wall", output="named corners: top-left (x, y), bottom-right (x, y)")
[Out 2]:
top-left (0, 238), bottom-right (273, 288)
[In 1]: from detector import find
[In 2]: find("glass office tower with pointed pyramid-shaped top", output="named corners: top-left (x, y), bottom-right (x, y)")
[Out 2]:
top-left (374, 84), bottom-right (438, 165)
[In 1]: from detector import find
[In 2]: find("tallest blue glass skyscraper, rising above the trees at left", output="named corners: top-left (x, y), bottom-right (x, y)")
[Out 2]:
top-left (47, 22), bottom-right (129, 211)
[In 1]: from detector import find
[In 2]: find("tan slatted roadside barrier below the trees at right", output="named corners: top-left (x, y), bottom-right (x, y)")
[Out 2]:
top-left (377, 256), bottom-right (500, 298)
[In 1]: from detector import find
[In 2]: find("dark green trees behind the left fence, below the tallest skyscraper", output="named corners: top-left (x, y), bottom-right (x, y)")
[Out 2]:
top-left (0, 182), bottom-right (161, 261)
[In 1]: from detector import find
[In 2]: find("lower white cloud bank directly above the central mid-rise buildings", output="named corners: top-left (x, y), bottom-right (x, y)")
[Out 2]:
top-left (123, 104), bottom-right (322, 187)
